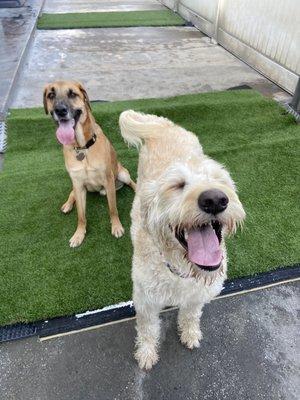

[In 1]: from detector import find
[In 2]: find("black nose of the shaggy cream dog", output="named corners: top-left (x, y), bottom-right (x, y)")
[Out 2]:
top-left (198, 189), bottom-right (229, 215)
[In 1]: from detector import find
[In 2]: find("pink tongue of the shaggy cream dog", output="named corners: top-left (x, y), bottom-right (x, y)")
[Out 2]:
top-left (187, 225), bottom-right (222, 267)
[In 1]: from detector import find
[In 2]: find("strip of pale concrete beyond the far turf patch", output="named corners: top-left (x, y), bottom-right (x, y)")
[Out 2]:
top-left (43, 0), bottom-right (165, 14)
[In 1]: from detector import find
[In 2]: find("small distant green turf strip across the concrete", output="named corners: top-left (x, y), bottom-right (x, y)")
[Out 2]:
top-left (37, 10), bottom-right (185, 29)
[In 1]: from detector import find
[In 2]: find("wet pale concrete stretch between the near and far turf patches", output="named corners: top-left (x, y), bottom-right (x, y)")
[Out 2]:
top-left (12, 27), bottom-right (278, 107)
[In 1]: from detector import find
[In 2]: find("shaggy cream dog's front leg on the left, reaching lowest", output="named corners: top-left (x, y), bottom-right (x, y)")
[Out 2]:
top-left (134, 303), bottom-right (160, 370)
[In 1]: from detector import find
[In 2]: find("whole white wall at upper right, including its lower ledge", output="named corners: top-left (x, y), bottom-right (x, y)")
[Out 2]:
top-left (162, 0), bottom-right (300, 93)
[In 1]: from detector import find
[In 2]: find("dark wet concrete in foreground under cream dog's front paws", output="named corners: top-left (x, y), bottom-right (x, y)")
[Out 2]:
top-left (0, 283), bottom-right (300, 400)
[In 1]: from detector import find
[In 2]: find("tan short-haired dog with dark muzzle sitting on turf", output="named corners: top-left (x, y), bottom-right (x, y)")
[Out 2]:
top-left (44, 81), bottom-right (135, 247)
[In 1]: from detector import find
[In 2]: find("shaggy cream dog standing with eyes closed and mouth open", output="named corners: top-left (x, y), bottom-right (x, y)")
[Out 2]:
top-left (119, 110), bottom-right (245, 369)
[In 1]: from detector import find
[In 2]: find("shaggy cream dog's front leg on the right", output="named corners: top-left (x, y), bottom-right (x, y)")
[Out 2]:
top-left (178, 304), bottom-right (203, 349)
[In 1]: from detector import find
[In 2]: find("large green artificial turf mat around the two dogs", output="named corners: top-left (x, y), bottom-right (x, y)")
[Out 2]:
top-left (0, 90), bottom-right (300, 325)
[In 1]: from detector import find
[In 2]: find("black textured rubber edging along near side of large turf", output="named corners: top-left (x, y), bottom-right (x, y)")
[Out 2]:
top-left (0, 264), bottom-right (300, 343)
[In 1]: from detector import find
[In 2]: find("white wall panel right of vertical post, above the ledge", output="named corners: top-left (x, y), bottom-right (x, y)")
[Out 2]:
top-left (216, 0), bottom-right (300, 73)
